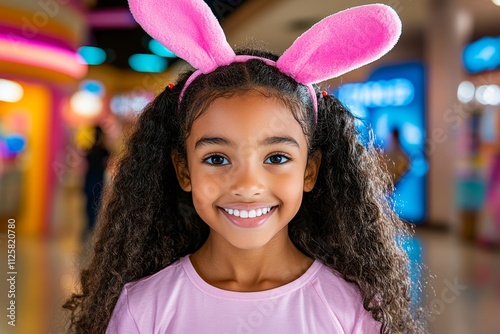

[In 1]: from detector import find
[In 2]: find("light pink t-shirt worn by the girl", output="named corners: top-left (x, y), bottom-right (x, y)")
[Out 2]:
top-left (106, 256), bottom-right (380, 334)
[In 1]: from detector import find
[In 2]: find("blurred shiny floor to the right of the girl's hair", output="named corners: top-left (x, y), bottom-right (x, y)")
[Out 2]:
top-left (417, 230), bottom-right (500, 334)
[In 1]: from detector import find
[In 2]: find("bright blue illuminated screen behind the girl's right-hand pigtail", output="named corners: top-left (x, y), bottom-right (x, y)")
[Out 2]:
top-left (335, 62), bottom-right (428, 223)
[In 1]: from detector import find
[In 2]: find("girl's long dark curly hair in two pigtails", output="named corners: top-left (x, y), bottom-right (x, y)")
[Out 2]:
top-left (64, 50), bottom-right (424, 334)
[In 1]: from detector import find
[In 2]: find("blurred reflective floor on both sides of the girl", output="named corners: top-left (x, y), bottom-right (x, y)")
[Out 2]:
top-left (0, 184), bottom-right (500, 334)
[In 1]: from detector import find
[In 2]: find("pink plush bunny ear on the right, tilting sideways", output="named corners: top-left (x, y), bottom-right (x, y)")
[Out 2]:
top-left (277, 4), bottom-right (401, 85)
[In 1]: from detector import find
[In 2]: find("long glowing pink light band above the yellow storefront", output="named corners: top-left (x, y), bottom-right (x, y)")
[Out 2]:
top-left (0, 34), bottom-right (87, 79)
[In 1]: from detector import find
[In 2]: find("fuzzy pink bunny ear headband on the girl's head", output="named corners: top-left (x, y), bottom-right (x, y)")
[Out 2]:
top-left (129, 0), bottom-right (401, 122)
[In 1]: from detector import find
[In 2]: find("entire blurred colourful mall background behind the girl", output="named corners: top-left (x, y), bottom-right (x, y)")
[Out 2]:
top-left (0, 0), bottom-right (500, 334)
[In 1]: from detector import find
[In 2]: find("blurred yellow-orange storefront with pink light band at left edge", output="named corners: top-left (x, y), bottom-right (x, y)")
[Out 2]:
top-left (0, 0), bottom-right (87, 235)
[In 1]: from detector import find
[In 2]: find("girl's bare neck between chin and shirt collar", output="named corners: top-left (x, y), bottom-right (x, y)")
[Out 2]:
top-left (190, 228), bottom-right (314, 292)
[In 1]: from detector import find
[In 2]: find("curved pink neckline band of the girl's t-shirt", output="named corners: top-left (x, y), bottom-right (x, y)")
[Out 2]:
top-left (179, 255), bottom-right (322, 300)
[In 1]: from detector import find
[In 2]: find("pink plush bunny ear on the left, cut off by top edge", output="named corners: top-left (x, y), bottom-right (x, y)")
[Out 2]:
top-left (128, 0), bottom-right (235, 73)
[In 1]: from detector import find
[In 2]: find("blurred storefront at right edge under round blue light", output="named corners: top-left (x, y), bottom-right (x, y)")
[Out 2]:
top-left (454, 36), bottom-right (500, 244)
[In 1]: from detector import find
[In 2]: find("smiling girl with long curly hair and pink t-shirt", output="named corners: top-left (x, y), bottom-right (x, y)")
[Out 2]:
top-left (65, 0), bottom-right (419, 334)
